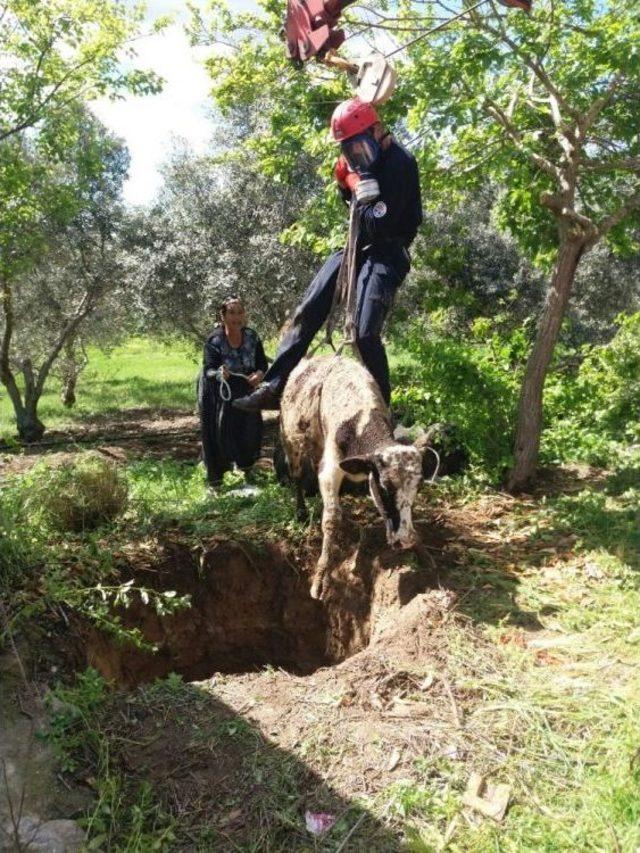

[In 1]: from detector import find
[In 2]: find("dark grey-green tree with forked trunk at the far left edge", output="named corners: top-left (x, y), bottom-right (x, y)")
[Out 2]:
top-left (0, 110), bottom-right (129, 441)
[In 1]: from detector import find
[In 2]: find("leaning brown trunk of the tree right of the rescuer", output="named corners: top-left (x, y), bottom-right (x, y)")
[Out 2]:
top-left (507, 237), bottom-right (585, 492)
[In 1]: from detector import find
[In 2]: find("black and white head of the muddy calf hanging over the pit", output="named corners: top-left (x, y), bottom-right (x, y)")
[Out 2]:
top-left (340, 444), bottom-right (422, 548)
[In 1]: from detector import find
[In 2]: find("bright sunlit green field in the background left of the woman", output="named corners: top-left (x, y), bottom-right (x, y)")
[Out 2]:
top-left (0, 338), bottom-right (201, 437)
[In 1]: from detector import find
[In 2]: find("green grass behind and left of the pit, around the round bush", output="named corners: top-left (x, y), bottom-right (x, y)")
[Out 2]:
top-left (0, 452), bottom-right (310, 644)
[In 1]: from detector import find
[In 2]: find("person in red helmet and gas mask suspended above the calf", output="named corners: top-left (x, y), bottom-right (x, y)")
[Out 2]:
top-left (233, 98), bottom-right (422, 412)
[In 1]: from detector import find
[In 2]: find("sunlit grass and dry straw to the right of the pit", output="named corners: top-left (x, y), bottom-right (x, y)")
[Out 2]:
top-left (392, 466), bottom-right (640, 853)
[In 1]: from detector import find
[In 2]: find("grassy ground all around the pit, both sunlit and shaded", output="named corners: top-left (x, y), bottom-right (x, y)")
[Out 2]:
top-left (2, 442), bottom-right (640, 853)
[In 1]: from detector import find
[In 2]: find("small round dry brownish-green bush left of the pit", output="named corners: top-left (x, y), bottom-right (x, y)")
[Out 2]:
top-left (29, 453), bottom-right (127, 533)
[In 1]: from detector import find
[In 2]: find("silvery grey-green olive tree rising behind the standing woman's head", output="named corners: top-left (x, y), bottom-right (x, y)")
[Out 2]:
top-left (128, 139), bottom-right (314, 346)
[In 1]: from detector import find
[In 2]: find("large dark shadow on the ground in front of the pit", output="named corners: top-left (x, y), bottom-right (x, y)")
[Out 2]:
top-left (102, 676), bottom-right (401, 853)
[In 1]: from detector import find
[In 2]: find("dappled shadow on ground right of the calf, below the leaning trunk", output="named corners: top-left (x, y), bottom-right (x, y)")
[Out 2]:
top-left (422, 464), bottom-right (640, 631)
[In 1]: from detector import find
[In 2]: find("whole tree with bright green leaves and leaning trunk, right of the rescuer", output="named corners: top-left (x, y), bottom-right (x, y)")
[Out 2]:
top-left (400, 0), bottom-right (640, 490)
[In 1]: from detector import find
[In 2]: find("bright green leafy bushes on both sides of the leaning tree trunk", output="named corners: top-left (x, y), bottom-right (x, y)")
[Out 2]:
top-left (391, 312), bottom-right (640, 480)
